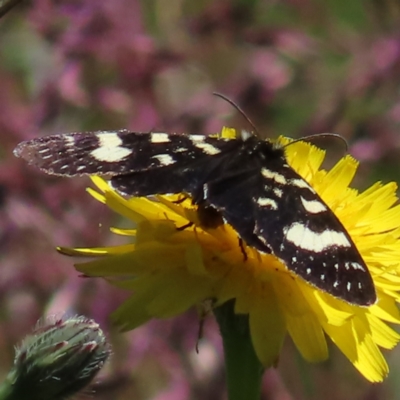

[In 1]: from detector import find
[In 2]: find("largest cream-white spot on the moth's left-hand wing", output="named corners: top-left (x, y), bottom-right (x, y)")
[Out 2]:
top-left (90, 133), bottom-right (132, 162)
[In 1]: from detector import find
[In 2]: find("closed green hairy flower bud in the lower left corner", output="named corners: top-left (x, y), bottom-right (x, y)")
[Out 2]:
top-left (2, 317), bottom-right (110, 400)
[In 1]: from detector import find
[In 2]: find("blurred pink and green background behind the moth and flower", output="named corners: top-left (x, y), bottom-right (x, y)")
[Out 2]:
top-left (0, 0), bottom-right (400, 400)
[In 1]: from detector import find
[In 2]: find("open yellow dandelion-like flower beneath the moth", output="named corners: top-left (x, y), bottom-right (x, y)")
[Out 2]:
top-left (59, 129), bottom-right (400, 382)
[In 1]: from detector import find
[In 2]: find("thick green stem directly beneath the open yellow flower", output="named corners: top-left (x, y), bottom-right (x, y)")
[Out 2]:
top-left (214, 301), bottom-right (264, 400)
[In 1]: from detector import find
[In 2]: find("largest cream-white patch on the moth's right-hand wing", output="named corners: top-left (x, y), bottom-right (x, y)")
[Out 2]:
top-left (284, 222), bottom-right (351, 253)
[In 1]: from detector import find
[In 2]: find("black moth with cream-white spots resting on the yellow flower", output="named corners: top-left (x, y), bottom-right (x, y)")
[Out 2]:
top-left (14, 130), bottom-right (376, 306)
